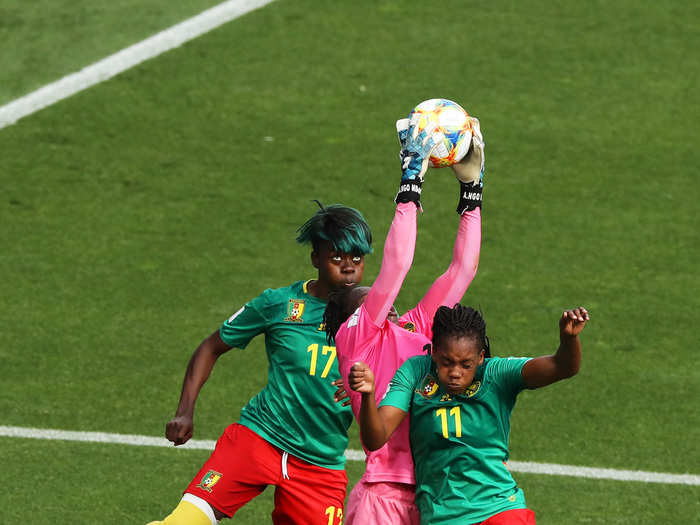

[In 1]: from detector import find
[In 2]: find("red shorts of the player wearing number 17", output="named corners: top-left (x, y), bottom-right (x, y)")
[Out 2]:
top-left (185, 423), bottom-right (348, 525)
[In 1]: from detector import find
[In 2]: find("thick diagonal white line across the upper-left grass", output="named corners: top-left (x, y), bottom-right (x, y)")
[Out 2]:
top-left (0, 0), bottom-right (273, 129)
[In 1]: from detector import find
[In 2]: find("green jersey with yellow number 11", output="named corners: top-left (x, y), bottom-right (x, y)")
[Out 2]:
top-left (380, 356), bottom-right (528, 525)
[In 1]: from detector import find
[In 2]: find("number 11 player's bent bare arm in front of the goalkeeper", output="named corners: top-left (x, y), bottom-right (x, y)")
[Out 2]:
top-left (348, 362), bottom-right (406, 450)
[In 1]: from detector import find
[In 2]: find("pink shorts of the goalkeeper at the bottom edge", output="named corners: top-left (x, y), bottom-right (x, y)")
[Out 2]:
top-left (345, 478), bottom-right (420, 525)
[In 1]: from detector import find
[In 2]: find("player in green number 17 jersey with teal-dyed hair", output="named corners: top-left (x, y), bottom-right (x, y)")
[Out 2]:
top-left (152, 205), bottom-right (372, 525)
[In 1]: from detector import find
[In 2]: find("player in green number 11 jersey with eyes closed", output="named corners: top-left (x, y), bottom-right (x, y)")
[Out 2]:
top-left (348, 304), bottom-right (589, 525)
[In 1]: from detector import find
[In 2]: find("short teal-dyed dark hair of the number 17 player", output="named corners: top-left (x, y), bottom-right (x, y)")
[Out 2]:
top-left (297, 201), bottom-right (372, 255)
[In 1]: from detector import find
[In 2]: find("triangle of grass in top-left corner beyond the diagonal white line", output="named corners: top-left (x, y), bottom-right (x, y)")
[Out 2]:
top-left (0, 0), bottom-right (226, 105)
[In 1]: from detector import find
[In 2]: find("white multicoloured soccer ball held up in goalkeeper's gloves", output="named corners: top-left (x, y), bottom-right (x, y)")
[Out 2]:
top-left (408, 98), bottom-right (472, 168)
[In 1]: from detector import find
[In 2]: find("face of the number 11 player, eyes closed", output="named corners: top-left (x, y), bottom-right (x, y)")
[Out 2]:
top-left (432, 337), bottom-right (484, 394)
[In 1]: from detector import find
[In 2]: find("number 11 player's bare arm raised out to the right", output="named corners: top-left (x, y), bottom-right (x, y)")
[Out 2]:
top-left (522, 306), bottom-right (590, 388)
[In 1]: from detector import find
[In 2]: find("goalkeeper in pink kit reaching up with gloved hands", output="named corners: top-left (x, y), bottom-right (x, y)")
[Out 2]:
top-left (324, 112), bottom-right (484, 525)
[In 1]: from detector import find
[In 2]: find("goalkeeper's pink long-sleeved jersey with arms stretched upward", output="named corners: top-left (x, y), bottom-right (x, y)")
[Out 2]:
top-left (335, 203), bottom-right (481, 484)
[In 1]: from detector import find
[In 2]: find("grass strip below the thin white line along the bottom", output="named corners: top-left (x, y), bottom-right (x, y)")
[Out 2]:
top-left (0, 438), bottom-right (700, 525)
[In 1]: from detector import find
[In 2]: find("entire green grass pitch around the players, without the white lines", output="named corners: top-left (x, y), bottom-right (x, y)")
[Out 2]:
top-left (0, 0), bottom-right (700, 525)
